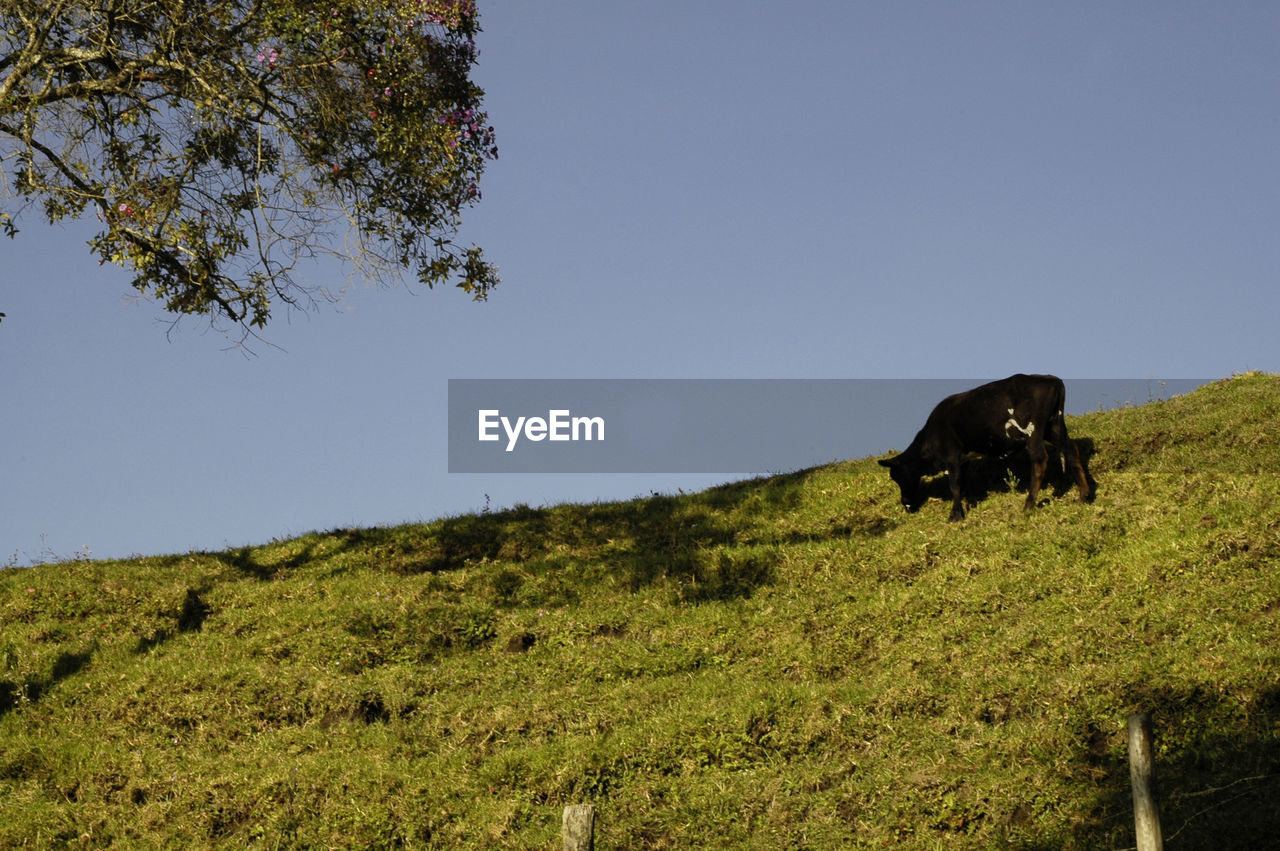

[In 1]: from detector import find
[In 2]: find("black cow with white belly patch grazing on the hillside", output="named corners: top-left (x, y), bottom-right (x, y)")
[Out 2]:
top-left (881, 374), bottom-right (1091, 520)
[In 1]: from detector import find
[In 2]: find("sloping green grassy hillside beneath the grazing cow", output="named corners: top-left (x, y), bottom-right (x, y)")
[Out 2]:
top-left (0, 375), bottom-right (1280, 848)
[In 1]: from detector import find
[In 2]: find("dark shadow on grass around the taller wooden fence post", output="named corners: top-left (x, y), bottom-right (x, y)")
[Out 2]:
top-left (1059, 683), bottom-right (1280, 851)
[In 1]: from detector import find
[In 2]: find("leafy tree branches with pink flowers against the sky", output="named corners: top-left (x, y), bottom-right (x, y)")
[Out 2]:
top-left (0, 0), bottom-right (498, 330)
